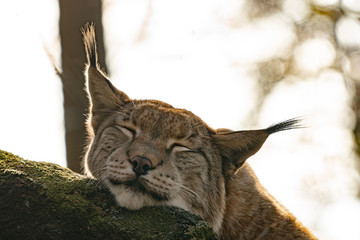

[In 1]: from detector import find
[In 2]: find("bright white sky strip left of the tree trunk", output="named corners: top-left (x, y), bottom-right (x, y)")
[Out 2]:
top-left (0, 0), bottom-right (66, 166)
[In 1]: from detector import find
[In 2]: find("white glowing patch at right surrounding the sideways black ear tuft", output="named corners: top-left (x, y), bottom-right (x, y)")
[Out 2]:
top-left (255, 70), bottom-right (360, 240)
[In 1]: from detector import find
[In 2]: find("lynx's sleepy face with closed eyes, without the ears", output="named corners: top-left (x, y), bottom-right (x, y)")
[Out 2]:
top-left (86, 97), bottom-right (224, 231)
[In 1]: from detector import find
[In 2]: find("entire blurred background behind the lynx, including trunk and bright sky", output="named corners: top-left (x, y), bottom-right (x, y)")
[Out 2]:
top-left (0, 0), bottom-right (360, 240)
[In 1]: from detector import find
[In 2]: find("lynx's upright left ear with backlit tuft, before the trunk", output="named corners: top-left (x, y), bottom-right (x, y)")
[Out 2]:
top-left (82, 24), bottom-right (130, 128)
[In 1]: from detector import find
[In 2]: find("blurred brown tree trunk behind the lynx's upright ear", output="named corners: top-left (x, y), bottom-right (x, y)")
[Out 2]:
top-left (59, 0), bottom-right (105, 173)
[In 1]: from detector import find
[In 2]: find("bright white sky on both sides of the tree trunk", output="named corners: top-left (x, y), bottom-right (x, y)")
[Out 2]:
top-left (0, 0), bottom-right (360, 240)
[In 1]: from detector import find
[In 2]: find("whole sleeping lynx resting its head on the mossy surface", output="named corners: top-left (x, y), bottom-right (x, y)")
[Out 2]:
top-left (83, 25), bottom-right (315, 239)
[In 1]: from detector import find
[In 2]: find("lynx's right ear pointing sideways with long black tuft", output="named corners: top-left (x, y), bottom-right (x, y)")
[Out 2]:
top-left (213, 119), bottom-right (300, 177)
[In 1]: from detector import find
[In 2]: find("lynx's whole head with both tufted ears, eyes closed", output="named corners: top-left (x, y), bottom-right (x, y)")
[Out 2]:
top-left (83, 25), bottom-right (296, 231)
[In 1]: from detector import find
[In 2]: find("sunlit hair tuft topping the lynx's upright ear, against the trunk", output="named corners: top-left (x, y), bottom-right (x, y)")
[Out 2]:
top-left (81, 23), bottom-right (98, 68)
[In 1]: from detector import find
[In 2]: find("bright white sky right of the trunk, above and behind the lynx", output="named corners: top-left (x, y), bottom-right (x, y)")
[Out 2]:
top-left (104, 1), bottom-right (359, 237)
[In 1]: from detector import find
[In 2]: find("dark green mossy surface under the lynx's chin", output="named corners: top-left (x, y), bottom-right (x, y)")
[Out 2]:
top-left (0, 150), bottom-right (216, 239)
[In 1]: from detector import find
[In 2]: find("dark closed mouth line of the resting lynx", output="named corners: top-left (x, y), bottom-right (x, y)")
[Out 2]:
top-left (108, 178), bottom-right (169, 201)
